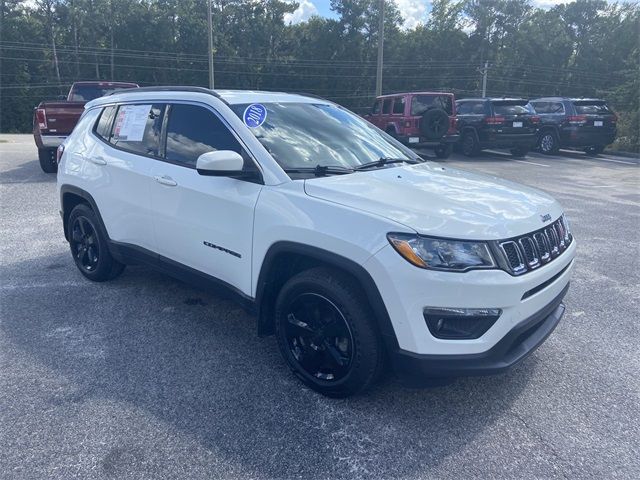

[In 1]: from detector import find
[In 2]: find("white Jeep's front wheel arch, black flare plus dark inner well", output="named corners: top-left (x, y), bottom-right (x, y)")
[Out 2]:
top-left (255, 241), bottom-right (398, 349)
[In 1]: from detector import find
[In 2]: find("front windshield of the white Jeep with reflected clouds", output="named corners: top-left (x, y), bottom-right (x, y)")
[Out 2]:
top-left (231, 103), bottom-right (417, 170)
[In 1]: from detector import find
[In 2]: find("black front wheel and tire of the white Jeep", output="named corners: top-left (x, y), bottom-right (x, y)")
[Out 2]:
top-left (275, 267), bottom-right (383, 398)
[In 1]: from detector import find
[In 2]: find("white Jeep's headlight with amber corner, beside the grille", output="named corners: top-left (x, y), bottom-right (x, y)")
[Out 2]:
top-left (387, 233), bottom-right (496, 272)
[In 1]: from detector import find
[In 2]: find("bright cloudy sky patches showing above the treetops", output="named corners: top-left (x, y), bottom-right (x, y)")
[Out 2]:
top-left (285, 0), bottom-right (608, 28)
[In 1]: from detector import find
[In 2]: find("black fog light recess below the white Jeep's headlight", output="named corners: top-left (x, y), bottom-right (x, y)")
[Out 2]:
top-left (423, 307), bottom-right (502, 340)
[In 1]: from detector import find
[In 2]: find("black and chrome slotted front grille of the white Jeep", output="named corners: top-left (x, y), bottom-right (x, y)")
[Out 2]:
top-left (498, 216), bottom-right (573, 275)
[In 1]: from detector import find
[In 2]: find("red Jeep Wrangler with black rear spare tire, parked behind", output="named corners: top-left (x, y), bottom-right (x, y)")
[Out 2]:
top-left (364, 92), bottom-right (459, 158)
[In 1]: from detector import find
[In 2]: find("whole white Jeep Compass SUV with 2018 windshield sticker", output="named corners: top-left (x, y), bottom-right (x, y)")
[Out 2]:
top-left (58, 87), bottom-right (576, 396)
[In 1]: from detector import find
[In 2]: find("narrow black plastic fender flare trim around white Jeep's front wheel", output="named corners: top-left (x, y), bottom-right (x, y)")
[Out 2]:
top-left (256, 241), bottom-right (399, 352)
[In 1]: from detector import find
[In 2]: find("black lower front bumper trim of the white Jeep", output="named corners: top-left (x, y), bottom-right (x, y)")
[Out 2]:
top-left (390, 284), bottom-right (569, 385)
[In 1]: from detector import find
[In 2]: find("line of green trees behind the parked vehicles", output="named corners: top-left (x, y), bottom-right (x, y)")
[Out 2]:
top-left (0, 0), bottom-right (640, 151)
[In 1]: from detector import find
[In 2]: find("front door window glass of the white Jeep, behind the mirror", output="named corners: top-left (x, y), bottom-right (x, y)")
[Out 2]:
top-left (166, 104), bottom-right (242, 167)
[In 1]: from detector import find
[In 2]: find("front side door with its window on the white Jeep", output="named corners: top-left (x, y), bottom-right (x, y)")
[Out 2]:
top-left (151, 104), bottom-right (262, 295)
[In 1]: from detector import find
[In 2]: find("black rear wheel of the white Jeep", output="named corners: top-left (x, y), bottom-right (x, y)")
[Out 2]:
top-left (67, 204), bottom-right (125, 282)
